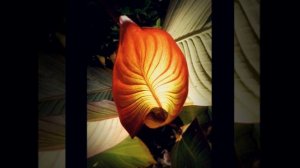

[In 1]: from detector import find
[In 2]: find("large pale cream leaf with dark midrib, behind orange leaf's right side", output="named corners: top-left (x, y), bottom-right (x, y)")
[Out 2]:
top-left (163, 0), bottom-right (212, 106)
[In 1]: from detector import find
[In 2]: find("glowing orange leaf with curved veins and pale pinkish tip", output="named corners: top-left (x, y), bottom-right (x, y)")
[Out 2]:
top-left (113, 16), bottom-right (188, 137)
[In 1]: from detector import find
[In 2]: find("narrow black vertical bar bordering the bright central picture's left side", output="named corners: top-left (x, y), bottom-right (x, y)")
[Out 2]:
top-left (66, 0), bottom-right (87, 168)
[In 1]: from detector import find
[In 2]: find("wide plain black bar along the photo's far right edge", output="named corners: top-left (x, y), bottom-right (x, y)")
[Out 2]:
top-left (261, 1), bottom-right (300, 167)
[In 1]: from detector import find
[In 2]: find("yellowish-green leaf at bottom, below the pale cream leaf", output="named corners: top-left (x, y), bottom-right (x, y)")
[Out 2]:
top-left (88, 137), bottom-right (156, 168)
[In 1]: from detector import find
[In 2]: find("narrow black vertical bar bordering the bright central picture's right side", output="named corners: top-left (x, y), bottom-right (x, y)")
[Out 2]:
top-left (212, 0), bottom-right (236, 168)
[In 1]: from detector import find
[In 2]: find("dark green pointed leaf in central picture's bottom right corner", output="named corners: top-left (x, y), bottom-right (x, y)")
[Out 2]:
top-left (171, 120), bottom-right (211, 168)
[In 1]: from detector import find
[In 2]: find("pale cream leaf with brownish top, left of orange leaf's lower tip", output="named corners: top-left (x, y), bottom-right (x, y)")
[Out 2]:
top-left (87, 101), bottom-right (129, 157)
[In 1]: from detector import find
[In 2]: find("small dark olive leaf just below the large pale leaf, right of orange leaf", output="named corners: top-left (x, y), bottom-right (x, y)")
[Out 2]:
top-left (179, 105), bottom-right (210, 125)
